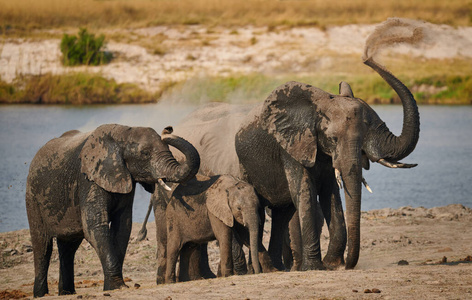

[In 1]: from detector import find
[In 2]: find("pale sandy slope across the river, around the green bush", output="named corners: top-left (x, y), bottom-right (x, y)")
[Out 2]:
top-left (0, 22), bottom-right (472, 91)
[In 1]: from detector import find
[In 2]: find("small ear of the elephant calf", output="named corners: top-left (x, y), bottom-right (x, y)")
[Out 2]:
top-left (206, 182), bottom-right (234, 227)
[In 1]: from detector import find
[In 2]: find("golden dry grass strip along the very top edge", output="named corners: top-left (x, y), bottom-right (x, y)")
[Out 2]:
top-left (0, 0), bottom-right (472, 32)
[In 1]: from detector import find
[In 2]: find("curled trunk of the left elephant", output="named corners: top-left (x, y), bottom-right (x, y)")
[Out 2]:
top-left (162, 134), bottom-right (200, 183)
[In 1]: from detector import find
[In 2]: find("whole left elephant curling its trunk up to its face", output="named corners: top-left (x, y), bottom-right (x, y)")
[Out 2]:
top-left (26, 124), bottom-right (200, 297)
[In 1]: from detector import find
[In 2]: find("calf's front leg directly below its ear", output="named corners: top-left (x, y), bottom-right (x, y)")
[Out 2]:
top-left (208, 214), bottom-right (234, 277)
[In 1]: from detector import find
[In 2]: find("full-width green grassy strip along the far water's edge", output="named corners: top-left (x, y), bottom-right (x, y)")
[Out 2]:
top-left (0, 73), bottom-right (472, 105)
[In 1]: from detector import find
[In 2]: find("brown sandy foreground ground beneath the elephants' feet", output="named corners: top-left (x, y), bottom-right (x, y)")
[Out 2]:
top-left (0, 205), bottom-right (472, 299)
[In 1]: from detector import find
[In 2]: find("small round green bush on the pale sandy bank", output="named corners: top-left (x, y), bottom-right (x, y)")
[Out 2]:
top-left (61, 28), bottom-right (112, 66)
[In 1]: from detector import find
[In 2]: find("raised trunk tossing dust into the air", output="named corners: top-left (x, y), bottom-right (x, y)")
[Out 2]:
top-left (364, 57), bottom-right (420, 162)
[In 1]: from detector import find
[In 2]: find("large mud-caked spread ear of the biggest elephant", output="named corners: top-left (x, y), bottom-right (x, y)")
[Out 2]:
top-left (262, 82), bottom-right (317, 167)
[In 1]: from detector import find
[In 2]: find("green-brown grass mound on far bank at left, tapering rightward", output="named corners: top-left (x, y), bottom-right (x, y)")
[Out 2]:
top-left (0, 73), bottom-right (159, 105)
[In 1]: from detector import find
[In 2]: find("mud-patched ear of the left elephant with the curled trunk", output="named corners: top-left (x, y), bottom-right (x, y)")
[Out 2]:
top-left (79, 125), bottom-right (133, 194)
